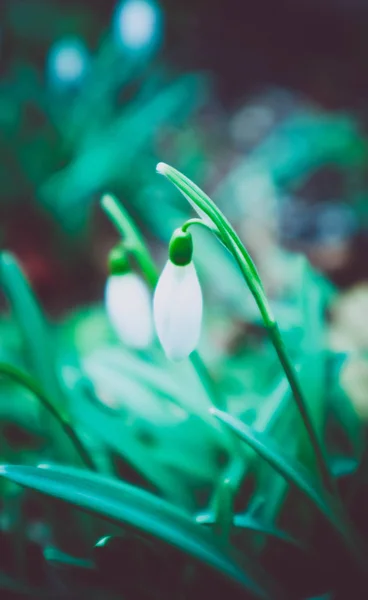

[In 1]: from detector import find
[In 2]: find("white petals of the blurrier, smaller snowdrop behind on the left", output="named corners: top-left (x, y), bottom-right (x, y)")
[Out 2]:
top-left (105, 273), bottom-right (153, 349)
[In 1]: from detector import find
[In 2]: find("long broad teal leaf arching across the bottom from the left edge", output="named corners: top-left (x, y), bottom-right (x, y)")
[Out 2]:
top-left (0, 465), bottom-right (282, 600)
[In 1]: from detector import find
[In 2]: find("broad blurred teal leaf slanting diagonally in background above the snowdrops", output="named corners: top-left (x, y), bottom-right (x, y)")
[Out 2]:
top-left (41, 75), bottom-right (207, 218)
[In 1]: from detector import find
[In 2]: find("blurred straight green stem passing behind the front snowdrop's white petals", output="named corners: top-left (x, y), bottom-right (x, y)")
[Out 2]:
top-left (101, 194), bottom-right (224, 408)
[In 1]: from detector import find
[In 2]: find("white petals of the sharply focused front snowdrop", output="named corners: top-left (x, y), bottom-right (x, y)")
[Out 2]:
top-left (153, 260), bottom-right (202, 360)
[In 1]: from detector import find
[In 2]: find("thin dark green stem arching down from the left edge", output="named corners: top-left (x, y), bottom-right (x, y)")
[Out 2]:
top-left (0, 363), bottom-right (97, 471)
